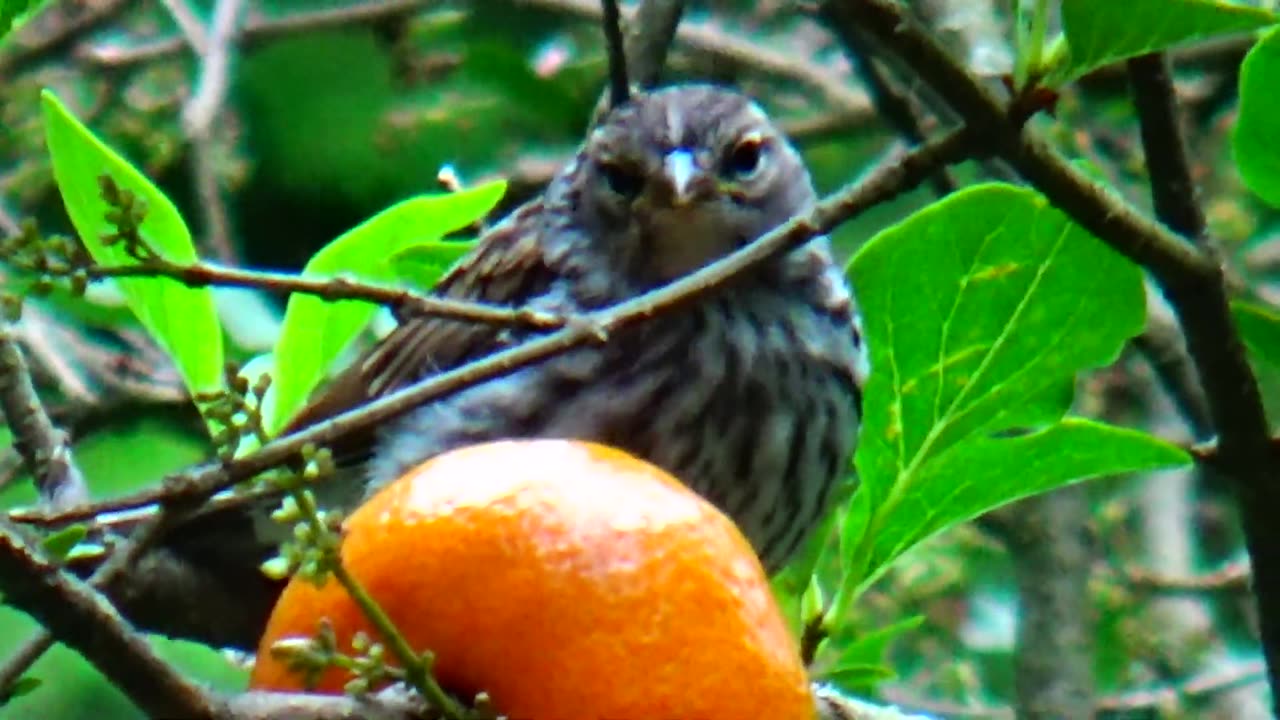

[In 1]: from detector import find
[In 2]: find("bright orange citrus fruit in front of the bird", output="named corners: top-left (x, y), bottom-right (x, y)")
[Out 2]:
top-left (251, 439), bottom-right (813, 720)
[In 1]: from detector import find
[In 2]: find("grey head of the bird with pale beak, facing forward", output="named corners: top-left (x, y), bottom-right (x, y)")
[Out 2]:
top-left (572, 86), bottom-right (814, 286)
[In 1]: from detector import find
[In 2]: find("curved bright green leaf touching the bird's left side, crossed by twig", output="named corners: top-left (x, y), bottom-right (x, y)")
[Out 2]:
top-left (266, 181), bottom-right (507, 434)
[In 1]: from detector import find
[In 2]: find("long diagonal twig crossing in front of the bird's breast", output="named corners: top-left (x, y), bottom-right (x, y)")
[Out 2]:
top-left (10, 124), bottom-right (975, 524)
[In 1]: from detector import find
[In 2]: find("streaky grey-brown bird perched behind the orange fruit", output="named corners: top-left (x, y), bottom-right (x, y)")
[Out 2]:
top-left (273, 85), bottom-right (863, 570)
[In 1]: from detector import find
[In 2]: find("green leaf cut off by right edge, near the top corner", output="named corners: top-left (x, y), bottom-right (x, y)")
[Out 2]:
top-left (1231, 29), bottom-right (1280, 208)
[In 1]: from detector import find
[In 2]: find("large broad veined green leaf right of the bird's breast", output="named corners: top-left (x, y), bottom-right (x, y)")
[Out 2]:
top-left (836, 184), bottom-right (1185, 591)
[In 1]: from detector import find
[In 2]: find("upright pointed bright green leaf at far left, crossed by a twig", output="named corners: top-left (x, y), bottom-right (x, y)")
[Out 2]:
top-left (41, 90), bottom-right (223, 392)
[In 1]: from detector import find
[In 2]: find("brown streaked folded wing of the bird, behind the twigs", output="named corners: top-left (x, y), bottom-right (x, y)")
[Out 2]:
top-left (284, 200), bottom-right (557, 448)
